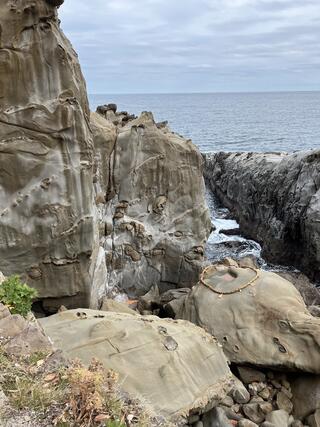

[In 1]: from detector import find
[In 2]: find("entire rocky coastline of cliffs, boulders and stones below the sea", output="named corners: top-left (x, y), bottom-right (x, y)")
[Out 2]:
top-left (0, 0), bottom-right (320, 427)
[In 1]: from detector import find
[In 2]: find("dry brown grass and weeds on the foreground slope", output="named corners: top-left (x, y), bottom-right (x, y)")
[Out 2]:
top-left (0, 348), bottom-right (158, 427)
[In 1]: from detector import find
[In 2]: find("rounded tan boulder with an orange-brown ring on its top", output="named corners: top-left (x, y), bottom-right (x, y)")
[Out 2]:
top-left (179, 264), bottom-right (320, 373)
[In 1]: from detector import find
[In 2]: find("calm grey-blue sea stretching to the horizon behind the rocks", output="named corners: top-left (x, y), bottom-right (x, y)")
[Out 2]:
top-left (90, 92), bottom-right (320, 152)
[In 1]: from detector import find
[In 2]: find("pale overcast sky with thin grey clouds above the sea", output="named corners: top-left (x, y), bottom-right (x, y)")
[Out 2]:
top-left (59, 0), bottom-right (320, 94)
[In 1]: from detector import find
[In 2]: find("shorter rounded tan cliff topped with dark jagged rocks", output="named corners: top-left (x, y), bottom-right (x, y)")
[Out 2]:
top-left (91, 111), bottom-right (211, 295)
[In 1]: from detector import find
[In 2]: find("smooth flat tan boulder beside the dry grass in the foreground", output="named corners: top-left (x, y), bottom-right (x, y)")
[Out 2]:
top-left (41, 310), bottom-right (233, 420)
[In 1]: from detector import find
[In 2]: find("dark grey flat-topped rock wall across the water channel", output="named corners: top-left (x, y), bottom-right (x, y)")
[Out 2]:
top-left (205, 150), bottom-right (320, 280)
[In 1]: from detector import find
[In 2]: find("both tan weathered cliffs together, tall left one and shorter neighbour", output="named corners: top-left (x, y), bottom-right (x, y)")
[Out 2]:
top-left (0, 0), bottom-right (211, 311)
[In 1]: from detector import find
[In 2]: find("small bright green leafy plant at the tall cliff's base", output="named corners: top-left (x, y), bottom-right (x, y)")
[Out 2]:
top-left (0, 276), bottom-right (37, 317)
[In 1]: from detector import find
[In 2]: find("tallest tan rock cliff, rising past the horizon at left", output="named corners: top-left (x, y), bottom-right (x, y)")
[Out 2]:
top-left (0, 0), bottom-right (94, 304)
